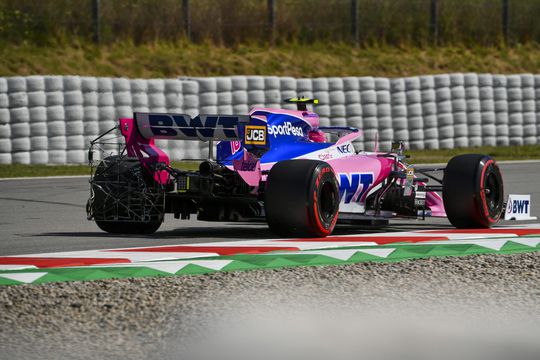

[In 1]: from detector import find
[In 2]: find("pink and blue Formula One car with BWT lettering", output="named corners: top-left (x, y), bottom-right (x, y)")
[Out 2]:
top-left (87, 98), bottom-right (503, 237)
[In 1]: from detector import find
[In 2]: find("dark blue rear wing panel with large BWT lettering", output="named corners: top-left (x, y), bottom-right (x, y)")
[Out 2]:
top-left (137, 112), bottom-right (250, 141)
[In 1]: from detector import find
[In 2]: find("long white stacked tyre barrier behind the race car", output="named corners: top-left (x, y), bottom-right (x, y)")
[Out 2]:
top-left (0, 73), bottom-right (540, 164)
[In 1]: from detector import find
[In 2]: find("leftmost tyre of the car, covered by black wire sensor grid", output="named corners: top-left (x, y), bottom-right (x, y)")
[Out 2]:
top-left (87, 155), bottom-right (163, 234)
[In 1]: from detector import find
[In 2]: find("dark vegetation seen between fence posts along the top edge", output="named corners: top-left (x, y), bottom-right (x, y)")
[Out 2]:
top-left (0, 0), bottom-right (540, 46)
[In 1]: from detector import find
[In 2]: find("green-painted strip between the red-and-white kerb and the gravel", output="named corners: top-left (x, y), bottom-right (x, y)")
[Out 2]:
top-left (0, 239), bottom-right (540, 285)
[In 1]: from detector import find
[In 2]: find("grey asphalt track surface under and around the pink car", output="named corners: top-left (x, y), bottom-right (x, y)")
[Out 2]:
top-left (0, 161), bottom-right (540, 255)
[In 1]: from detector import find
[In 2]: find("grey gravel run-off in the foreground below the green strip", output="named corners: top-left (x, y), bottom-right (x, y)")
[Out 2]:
top-left (0, 252), bottom-right (540, 360)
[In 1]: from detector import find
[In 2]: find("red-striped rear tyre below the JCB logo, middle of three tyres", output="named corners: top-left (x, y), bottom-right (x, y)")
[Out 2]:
top-left (264, 160), bottom-right (339, 237)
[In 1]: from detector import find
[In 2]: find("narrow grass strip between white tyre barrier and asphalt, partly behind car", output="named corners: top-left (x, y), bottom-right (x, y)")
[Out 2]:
top-left (0, 145), bottom-right (540, 178)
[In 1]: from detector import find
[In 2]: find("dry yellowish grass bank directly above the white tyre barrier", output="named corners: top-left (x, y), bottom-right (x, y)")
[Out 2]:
top-left (0, 41), bottom-right (540, 78)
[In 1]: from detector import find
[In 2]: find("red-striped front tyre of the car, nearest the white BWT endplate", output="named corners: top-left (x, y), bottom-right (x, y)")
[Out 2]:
top-left (443, 154), bottom-right (504, 229)
